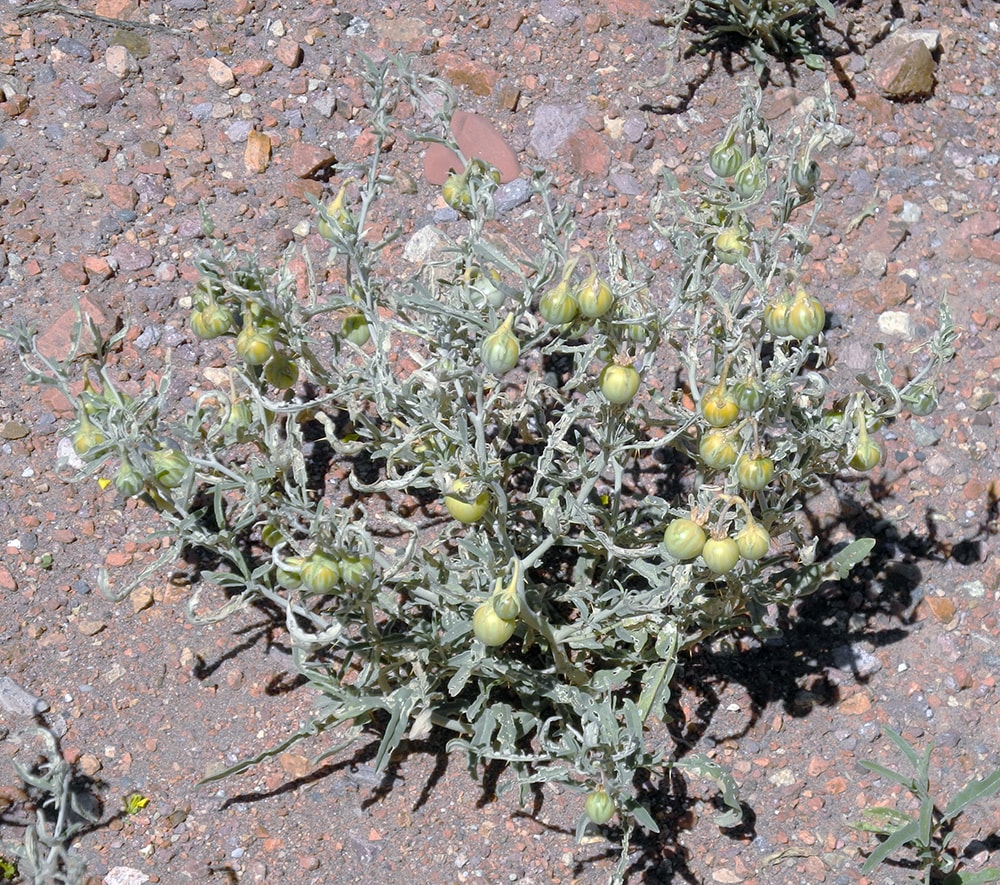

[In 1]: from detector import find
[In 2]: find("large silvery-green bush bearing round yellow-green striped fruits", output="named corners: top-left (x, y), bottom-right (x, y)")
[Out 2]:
top-left (0, 58), bottom-right (952, 874)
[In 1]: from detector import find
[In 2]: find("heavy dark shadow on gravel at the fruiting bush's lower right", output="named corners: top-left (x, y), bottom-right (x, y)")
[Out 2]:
top-left (612, 484), bottom-right (1000, 885)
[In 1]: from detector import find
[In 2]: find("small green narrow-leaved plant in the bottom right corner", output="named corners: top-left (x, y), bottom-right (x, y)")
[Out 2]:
top-left (853, 728), bottom-right (1000, 885)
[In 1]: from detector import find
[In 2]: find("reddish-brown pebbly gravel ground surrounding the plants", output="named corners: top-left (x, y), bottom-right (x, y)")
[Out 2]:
top-left (0, 0), bottom-right (1000, 885)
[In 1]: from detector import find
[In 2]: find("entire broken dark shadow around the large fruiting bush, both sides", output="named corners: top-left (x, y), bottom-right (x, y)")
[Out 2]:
top-left (196, 483), bottom-right (1000, 885)
